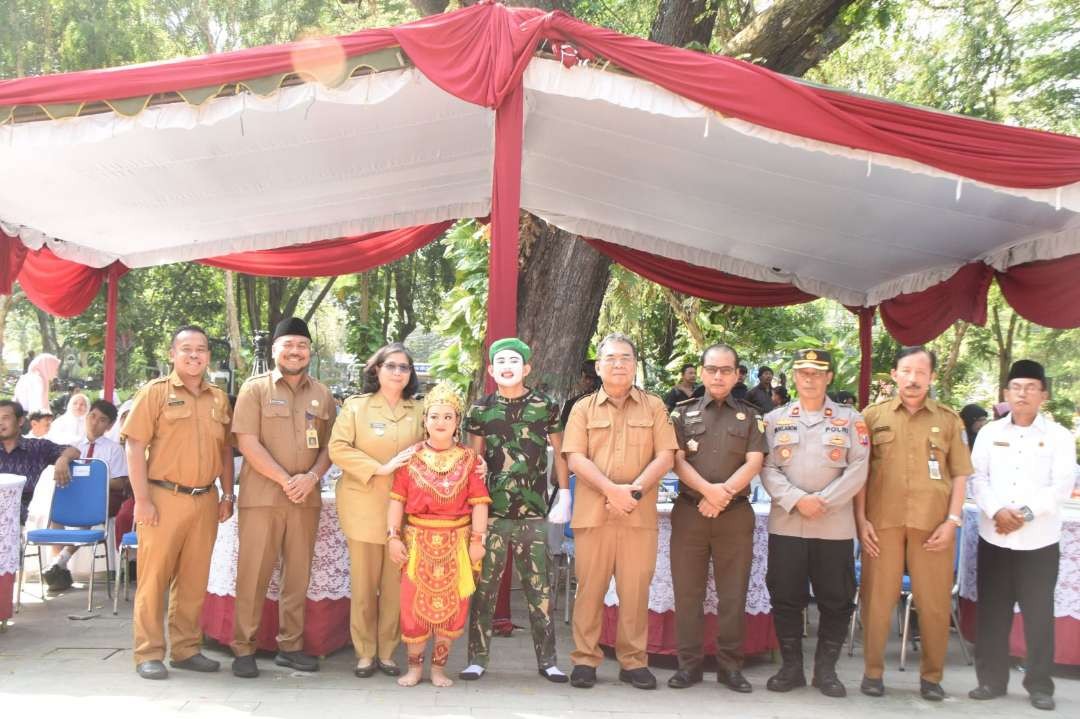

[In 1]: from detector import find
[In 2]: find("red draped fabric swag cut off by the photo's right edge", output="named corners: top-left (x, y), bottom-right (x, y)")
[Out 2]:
top-left (997, 255), bottom-right (1080, 329)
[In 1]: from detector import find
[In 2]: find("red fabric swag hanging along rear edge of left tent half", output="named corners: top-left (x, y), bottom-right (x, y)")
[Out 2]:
top-left (199, 221), bottom-right (454, 277)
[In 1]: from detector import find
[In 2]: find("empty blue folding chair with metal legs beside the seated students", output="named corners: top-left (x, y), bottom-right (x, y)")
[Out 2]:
top-left (15, 459), bottom-right (112, 612)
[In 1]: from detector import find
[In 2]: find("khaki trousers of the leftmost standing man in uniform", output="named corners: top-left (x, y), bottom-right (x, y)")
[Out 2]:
top-left (133, 485), bottom-right (218, 665)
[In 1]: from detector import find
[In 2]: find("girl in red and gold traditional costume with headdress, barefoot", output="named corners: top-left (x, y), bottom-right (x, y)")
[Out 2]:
top-left (387, 384), bottom-right (491, 687)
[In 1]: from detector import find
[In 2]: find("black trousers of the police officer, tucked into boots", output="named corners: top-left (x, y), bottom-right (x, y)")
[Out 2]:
top-left (765, 534), bottom-right (855, 642)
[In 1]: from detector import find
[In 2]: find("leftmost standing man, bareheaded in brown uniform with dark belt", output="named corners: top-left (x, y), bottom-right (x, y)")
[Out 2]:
top-left (123, 325), bottom-right (237, 679)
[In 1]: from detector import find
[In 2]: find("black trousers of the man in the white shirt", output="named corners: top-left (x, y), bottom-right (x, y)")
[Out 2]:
top-left (975, 538), bottom-right (1061, 694)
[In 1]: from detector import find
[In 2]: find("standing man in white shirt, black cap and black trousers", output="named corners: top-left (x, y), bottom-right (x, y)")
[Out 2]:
top-left (968, 360), bottom-right (1076, 709)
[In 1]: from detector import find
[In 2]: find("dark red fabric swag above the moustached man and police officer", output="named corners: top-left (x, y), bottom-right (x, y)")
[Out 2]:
top-left (880, 262), bottom-right (994, 344)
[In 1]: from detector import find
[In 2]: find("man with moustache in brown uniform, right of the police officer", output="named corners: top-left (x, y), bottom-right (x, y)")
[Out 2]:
top-left (855, 347), bottom-right (972, 702)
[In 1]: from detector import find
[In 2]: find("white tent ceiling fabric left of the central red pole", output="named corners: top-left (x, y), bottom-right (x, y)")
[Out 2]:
top-left (0, 68), bottom-right (495, 267)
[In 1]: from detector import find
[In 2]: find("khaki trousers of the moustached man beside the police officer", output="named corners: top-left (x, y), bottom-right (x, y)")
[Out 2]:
top-left (860, 527), bottom-right (956, 682)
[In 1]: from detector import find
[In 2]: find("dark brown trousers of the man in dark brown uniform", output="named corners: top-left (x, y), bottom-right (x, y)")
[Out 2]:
top-left (671, 500), bottom-right (755, 671)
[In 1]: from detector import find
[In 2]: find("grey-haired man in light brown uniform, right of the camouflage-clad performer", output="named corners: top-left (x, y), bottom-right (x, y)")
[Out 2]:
top-left (563, 334), bottom-right (678, 689)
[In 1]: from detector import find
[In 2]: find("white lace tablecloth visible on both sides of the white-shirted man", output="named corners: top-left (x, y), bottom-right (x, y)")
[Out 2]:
top-left (958, 504), bottom-right (1080, 620)
